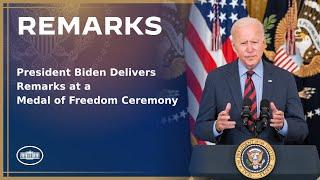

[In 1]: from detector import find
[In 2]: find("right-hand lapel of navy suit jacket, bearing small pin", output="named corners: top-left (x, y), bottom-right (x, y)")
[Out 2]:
top-left (262, 62), bottom-right (274, 101)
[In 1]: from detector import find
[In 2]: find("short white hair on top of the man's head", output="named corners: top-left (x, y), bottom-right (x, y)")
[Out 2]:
top-left (231, 17), bottom-right (264, 37)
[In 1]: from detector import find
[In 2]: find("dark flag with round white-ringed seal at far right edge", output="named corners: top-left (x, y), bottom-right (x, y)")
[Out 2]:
top-left (294, 0), bottom-right (320, 155)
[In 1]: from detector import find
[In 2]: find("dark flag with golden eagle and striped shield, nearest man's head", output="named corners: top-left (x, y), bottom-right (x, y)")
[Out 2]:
top-left (263, 0), bottom-right (301, 72)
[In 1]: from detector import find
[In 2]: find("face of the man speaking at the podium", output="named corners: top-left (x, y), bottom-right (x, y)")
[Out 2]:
top-left (232, 24), bottom-right (266, 70)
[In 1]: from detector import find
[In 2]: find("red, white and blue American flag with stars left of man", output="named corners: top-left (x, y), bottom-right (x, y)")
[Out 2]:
top-left (184, 0), bottom-right (248, 144)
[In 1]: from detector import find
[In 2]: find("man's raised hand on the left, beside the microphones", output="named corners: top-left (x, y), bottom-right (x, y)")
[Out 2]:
top-left (215, 103), bottom-right (236, 132)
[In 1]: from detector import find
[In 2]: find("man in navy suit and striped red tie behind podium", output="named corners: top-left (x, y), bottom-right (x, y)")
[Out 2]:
top-left (195, 17), bottom-right (308, 144)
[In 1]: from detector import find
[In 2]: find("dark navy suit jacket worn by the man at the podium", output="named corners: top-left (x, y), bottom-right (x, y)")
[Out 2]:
top-left (195, 61), bottom-right (308, 144)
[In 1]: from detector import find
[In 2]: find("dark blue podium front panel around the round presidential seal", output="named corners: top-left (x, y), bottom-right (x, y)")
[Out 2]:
top-left (190, 145), bottom-right (320, 180)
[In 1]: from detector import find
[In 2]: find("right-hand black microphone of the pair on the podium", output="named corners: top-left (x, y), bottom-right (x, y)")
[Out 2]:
top-left (257, 99), bottom-right (271, 133)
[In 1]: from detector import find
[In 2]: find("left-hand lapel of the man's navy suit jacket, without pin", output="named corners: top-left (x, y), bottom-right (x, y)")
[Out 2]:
top-left (226, 61), bottom-right (242, 112)
